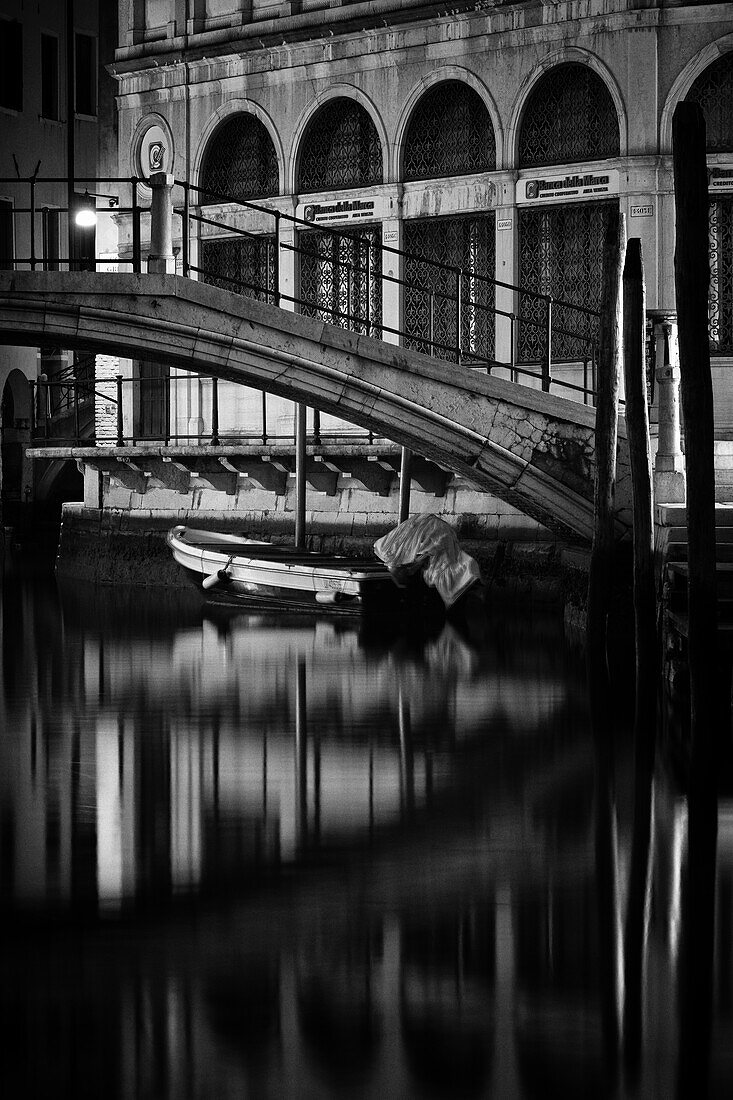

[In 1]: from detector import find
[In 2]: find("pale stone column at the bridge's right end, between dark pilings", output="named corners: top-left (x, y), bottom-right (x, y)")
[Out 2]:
top-left (653, 315), bottom-right (686, 504)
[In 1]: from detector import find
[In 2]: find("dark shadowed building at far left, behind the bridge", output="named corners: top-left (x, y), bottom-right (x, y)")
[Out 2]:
top-left (0, 0), bottom-right (117, 525)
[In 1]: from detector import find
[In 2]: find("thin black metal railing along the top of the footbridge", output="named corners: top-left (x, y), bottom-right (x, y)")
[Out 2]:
top-left (0, 176), bottom-right (599, 441)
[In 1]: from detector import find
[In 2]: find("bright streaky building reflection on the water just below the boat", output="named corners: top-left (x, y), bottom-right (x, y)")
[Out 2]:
top-left (0, 583), bottom-right (566, 910)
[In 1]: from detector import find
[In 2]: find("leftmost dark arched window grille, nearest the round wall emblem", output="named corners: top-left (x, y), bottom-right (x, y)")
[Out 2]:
top-left (201, 112), bottom-right (278, 204)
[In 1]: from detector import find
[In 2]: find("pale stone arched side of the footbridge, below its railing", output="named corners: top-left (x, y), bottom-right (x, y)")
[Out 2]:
top-left (0, 272), bottom-right (631, 540)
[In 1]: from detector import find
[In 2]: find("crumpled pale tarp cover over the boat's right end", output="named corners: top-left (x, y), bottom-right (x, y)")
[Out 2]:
top-left (374, 515), bottom-right (481, 607)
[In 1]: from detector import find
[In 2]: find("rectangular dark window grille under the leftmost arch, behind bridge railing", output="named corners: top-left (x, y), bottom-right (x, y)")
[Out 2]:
top-left (200, 235), bottom-right (275, 301)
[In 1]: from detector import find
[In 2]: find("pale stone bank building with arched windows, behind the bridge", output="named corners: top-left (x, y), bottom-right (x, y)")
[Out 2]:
top-left (8, 0), bottom-right (733, 537)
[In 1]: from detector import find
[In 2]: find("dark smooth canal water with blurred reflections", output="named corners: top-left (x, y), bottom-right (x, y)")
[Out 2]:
top-left (0, 562), bottom-right (733, 1100)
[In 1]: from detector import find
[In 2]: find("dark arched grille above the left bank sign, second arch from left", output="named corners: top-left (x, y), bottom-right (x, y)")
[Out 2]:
top-left (298, 98), bottom-right (382, 191)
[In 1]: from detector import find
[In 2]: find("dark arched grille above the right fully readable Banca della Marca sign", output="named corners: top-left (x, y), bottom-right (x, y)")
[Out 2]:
top-left (519, 62), bottom-right (621, 168)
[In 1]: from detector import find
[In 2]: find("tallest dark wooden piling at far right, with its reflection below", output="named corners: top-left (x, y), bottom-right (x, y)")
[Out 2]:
top-left (672, 96), bottom-right (717, 1097)
